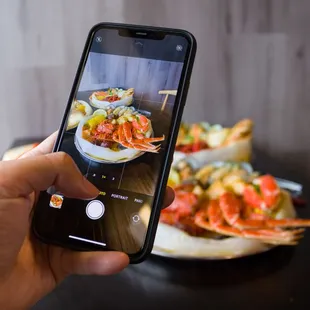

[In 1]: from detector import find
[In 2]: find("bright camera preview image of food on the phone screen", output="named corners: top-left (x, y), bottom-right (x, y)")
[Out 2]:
top-left (61, 35), bottom-right (183, 195)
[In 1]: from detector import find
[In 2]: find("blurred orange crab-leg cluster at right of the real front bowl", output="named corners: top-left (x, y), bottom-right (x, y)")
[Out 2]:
top-left (195, 175), bottom-right (310, 244)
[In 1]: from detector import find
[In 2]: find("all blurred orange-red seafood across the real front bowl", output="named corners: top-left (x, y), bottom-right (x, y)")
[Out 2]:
top-left (161, 175), bottom-right (310, 245)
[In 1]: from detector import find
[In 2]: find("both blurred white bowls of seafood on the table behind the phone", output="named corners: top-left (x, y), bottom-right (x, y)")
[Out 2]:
top-left (140, 119), bottom-right (310, 260)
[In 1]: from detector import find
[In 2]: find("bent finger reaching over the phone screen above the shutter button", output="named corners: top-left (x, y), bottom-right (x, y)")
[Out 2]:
top-left (0, 152), bottom-right (99, 199)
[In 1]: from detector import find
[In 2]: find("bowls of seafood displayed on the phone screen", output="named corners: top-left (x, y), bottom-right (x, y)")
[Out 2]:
top-left (67, 88), bottom-right (165, 164)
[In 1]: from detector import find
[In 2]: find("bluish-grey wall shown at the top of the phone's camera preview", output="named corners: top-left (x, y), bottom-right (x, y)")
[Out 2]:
top-left (79, 53), bottom-right (183, 103)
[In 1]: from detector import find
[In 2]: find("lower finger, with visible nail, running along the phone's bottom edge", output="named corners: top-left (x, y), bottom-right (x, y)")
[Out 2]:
top-left (49, 247), bottom-right (129, 282)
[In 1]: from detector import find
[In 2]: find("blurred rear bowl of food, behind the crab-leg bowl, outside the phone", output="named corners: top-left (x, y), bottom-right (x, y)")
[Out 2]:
top-left (173, 119), bottom-right (253, 166)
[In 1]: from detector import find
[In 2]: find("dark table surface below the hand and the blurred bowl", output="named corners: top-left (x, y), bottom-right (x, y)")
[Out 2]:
top-left (6, 138), bottom-right (310, 310)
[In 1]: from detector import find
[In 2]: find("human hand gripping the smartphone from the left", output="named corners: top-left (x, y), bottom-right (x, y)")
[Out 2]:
top-left (0, 133), bottom-right (174, 309)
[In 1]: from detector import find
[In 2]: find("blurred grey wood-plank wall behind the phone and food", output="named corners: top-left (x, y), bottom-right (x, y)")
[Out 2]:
top-left (0, 0), bottom-right (310, 181)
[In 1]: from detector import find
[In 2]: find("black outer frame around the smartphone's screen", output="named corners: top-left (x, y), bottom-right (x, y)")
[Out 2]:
top-left (32, 23), bottom-right (196, 263)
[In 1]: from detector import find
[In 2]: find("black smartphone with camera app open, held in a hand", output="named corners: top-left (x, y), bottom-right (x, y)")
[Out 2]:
top-left (32, 23), bottom-right (196, 263)
